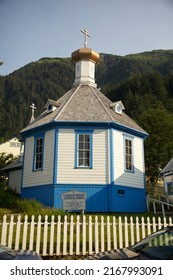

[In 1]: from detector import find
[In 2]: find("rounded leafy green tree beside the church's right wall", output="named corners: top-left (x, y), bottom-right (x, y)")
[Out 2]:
top-left (138, 108), bottom-right (173, 183)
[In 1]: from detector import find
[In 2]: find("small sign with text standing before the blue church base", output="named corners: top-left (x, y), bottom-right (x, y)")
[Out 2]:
top-left (62, 190), bottom-right (86, 210)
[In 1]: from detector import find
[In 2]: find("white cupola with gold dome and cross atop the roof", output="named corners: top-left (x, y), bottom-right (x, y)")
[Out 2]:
top-left (72, 30), bottom-right (99, 87)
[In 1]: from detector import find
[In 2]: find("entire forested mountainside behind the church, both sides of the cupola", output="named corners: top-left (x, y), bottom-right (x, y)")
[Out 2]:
top-left (0, 50), bottom-right (173, 138)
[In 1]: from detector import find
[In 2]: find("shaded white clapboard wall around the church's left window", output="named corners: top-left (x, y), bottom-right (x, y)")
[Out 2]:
top-left (23, 130), bottom-right (55, 187)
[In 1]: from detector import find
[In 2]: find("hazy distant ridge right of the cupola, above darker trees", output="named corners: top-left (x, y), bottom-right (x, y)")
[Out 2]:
top-left (96, 50), bottom-right (173, 86)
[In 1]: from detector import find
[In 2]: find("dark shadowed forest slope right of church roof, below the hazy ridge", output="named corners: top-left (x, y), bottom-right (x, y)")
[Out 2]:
top-left (106, 72), bottom-right (173, 120)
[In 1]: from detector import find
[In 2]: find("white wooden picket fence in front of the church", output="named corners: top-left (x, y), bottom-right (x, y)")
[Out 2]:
top-left (0, 215), bottom-right (173, 256)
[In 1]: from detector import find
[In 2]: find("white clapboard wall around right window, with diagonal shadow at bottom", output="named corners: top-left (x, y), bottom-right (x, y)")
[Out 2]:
top-left (113, 130), bottom-right (144, 188)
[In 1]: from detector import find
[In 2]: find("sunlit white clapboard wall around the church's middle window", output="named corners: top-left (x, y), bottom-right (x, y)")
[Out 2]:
top-left (57, 129), bottom-right (107, 184)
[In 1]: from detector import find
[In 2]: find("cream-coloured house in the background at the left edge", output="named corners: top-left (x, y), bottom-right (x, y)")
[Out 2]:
top-left (0, 137), bottom-right (21, 157)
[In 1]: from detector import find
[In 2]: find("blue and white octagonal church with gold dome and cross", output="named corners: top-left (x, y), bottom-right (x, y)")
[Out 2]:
top-left (21, 30), bottom-right (148, 212)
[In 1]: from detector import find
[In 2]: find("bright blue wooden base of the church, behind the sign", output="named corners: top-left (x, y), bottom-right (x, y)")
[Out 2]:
top-left (21, 184), bottom-right (146, 212)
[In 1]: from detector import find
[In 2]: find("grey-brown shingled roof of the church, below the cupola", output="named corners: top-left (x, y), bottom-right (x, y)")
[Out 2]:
top-left (21, 84), bottom-right (147, 135)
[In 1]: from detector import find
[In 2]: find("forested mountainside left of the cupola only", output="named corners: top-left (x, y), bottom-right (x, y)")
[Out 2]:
top-left (0, 58), bottom-right (74, 138)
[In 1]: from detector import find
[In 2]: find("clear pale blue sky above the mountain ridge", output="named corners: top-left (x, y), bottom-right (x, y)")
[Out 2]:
top-left (0, 0), bottom-right (173, 75)
